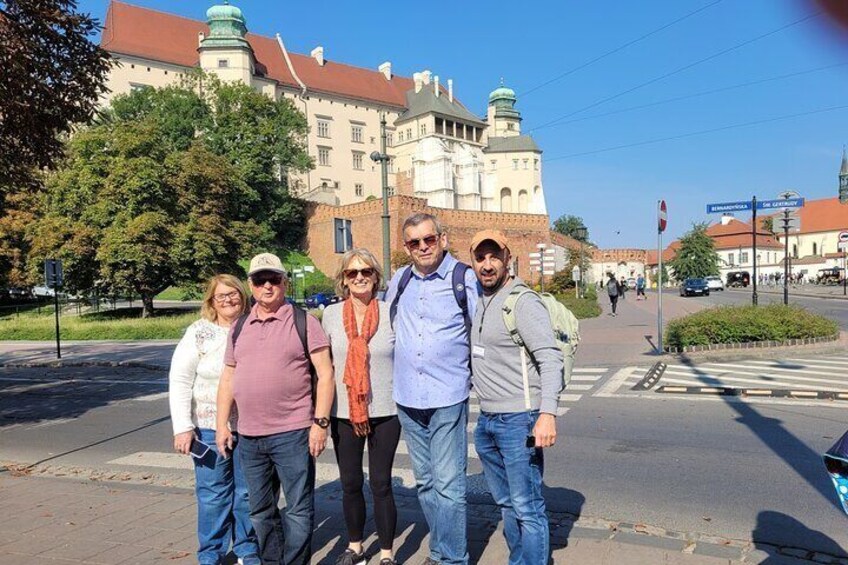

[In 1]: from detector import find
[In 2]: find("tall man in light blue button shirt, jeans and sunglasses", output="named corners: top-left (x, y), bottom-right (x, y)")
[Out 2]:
top-left (386, 213), bottom-right (478, 564)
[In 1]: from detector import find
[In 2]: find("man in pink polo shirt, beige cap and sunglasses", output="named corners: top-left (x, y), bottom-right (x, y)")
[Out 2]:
top-left (216, 253), bottom-right (335, 565)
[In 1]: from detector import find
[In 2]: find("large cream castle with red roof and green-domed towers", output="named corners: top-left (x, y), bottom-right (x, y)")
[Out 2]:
top-left (101, 0), bottom-right (546, 214)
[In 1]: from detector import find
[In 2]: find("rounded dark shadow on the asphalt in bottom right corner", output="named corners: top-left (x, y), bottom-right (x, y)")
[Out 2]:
top-left (751, 510), bottom-right (845, 565)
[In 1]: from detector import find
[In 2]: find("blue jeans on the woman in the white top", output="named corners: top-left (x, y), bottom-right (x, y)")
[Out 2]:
top-left (192, 428), bottom-right (259, 565)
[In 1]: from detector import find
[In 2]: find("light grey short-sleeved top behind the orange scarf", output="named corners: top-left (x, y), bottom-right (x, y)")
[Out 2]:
top-left (321, 301), bottom-right (397, 420)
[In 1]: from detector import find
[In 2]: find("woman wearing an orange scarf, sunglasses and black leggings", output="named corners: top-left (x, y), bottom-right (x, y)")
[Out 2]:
top-left (322, 248), bottom-right (400, 565)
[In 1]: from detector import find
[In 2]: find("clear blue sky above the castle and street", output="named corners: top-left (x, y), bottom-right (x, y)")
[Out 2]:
top-left (80, 0), bottom-right (848, 247)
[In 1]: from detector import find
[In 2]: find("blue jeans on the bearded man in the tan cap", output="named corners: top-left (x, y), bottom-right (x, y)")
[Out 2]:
top-left (474, 411), bottom-right (550, 565)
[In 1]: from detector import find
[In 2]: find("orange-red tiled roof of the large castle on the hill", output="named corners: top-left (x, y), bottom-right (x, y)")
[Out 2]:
top-left (100, 0), bottom-right (415, 108)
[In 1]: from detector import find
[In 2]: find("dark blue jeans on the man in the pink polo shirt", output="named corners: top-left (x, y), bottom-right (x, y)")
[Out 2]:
top-left (239, 428), bottom-right (315, 565)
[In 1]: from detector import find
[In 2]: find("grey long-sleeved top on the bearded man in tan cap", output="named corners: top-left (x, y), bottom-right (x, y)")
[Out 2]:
top-left (471, 277), bottom-right (563, 415)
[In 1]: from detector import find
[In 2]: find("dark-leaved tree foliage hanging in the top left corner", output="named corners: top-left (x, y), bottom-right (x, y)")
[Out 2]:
top-left (0, 0), bottom-right (109, 203)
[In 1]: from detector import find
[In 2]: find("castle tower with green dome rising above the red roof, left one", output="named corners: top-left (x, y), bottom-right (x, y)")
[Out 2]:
top-left (197, 0), bottom-right (253, 85)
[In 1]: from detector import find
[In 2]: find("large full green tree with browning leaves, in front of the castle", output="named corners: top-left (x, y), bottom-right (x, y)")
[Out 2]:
top-left (30, 81), bottom-right (311, 316)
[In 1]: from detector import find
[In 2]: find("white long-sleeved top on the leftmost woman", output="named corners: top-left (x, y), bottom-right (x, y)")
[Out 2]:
top-left (168, 319), bottom-right (238, 435)
